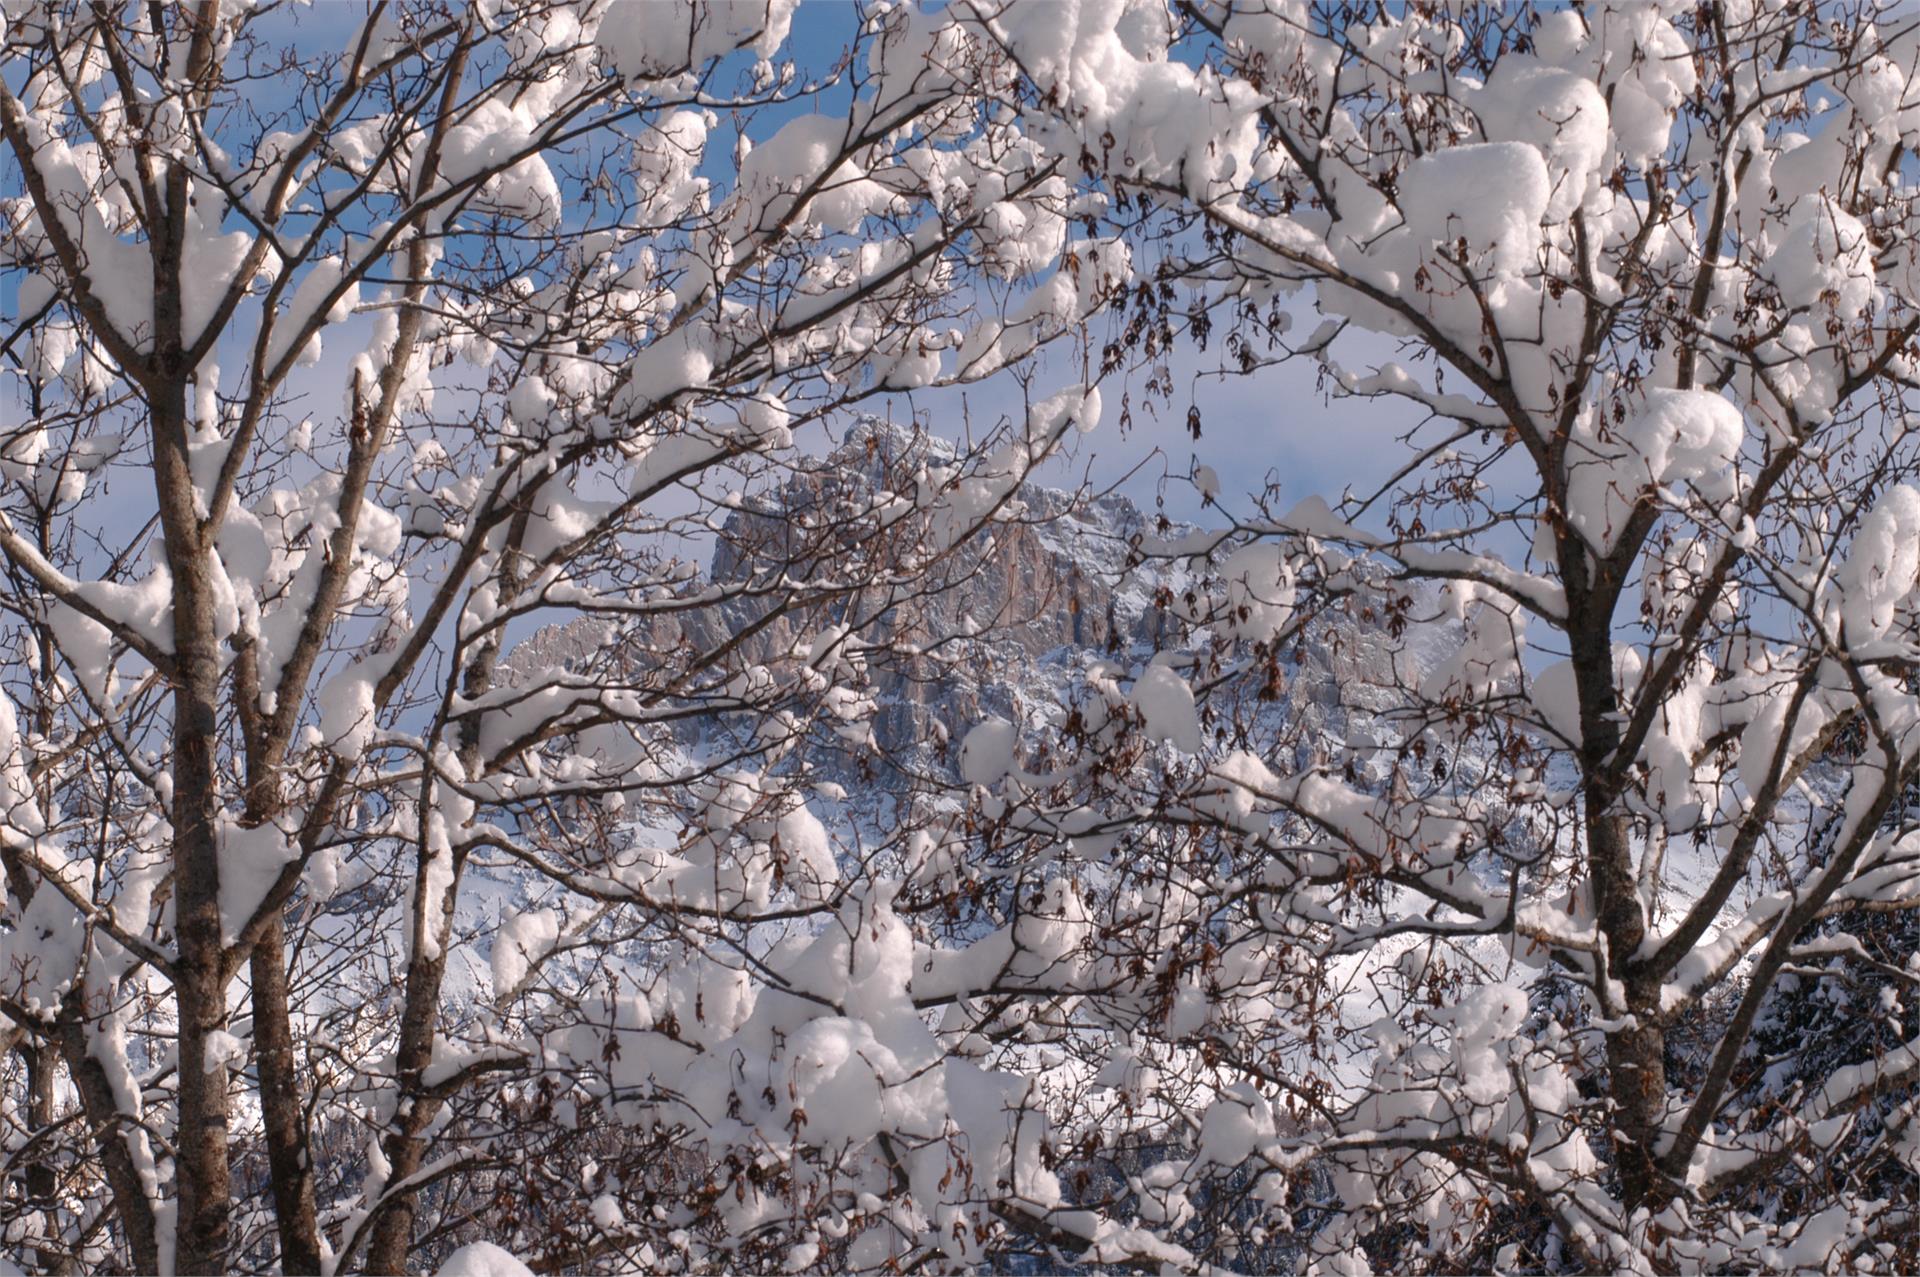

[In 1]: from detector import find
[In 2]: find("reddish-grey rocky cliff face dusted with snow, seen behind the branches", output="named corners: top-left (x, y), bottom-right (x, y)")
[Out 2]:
top-left (507, 421), bottom-right (1394, 772)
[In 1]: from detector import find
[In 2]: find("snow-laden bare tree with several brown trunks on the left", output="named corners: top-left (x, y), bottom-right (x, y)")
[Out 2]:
top-left (0, 0), bottom-right (1129, 1273)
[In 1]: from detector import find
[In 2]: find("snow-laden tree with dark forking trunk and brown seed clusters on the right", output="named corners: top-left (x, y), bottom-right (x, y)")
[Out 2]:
top-left (944, 0), bottom-right (1920, 1271)
